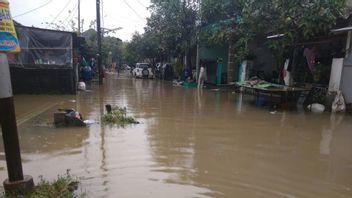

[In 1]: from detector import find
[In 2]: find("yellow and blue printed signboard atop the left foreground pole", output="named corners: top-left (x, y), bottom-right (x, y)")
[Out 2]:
top-left (0, 0), bottom-right (21, 53)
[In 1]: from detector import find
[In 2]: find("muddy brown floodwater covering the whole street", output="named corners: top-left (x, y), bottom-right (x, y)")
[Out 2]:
top-left (0, 72), bottom-right (352, 198)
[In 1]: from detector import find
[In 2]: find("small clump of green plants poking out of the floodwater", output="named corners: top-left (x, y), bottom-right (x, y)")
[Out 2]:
top-left (102, 106), bottom-right (139, 126)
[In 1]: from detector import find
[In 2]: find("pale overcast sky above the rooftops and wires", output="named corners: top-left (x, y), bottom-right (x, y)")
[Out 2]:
top-left (9, 0), bottom-right (150, 41)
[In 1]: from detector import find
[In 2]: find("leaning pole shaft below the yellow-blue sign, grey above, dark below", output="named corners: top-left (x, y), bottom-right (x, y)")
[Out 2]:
top-left (0, 53), bottom-right (23, 182)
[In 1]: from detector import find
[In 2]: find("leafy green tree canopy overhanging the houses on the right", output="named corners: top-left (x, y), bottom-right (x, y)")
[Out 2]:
top-left (202, 0), bottom-right (346, 79)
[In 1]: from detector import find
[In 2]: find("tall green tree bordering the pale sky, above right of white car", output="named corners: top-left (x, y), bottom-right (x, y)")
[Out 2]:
top-left (145, 0), bottom-right (198, 64)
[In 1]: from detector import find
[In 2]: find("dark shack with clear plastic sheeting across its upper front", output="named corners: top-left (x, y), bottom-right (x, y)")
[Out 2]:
top-left (8, 24), bottom-right (82, 94)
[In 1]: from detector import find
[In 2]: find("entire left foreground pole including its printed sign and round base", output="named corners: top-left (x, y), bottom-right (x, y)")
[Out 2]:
top-left (0, 0), bottom-right (34, 195)
